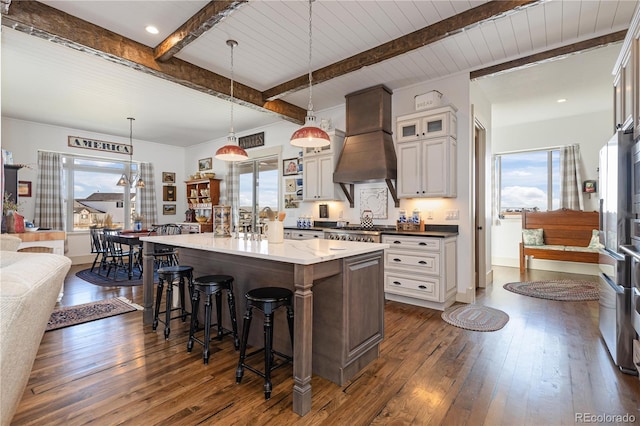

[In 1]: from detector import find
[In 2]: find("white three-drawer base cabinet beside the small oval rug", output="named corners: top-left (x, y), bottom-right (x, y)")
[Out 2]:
top-left (382, 235), bottom-right (458, 310)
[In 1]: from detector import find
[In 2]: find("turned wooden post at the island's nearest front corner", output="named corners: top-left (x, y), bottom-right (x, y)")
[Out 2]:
top-left (293, 265), bottom-right (314, 416)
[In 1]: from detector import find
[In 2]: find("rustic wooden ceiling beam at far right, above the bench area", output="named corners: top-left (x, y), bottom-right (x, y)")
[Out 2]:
top-left (469, 30), bottom-right (627, 80)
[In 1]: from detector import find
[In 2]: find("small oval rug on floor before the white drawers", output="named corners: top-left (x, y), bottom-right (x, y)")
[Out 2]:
top-left (441, 304), bottom-right (509, 331)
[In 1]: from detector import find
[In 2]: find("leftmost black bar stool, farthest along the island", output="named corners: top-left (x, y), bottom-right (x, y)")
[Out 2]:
top-left (153, 265), bottom-right (193, 339)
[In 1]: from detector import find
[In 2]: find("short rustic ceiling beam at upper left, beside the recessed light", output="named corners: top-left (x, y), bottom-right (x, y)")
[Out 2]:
top-left (153, 0), bottom-right (248, 62)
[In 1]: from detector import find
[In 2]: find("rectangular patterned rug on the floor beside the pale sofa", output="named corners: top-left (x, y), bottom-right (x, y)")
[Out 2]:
top-left (45, 297), bottom-right (142, 331)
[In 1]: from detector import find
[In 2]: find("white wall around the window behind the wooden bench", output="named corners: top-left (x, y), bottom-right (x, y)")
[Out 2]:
top-left (492, 109), bottom-right (613, 273)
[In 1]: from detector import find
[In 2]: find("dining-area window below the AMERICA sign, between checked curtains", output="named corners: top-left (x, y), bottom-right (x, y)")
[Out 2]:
top-left (63, 154), bottom-right (138, 231)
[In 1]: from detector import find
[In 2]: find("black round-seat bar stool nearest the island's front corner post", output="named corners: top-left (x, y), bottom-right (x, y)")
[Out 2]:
top-left (236, 287), bottom-right (293, 399)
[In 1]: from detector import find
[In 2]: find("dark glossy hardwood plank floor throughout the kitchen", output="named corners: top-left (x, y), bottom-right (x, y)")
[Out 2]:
top-left (12, 265), bottom-right (640, 426)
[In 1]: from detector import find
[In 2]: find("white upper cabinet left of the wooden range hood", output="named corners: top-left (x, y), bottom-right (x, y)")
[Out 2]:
top-left (302, 130), bottom-right (344, 201)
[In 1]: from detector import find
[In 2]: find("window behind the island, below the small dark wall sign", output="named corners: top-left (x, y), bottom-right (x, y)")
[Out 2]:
top-left (238, 156), bottom-right (280, 229)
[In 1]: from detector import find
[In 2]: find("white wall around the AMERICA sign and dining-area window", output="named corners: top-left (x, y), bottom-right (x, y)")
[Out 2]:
top-left (2, 117), bottom-right (186, 263)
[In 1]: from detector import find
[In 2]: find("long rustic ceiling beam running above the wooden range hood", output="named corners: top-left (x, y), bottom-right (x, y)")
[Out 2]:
top-left (263, 0), bottom-right (540, 100)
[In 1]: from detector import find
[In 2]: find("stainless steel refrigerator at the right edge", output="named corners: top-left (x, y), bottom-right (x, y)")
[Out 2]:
top-left (599, 131), bottom-right (636, 374)
